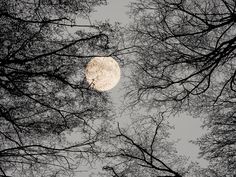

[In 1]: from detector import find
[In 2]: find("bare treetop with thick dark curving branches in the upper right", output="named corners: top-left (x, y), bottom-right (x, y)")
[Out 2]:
top-left (130, 0), bottom-right (236, 108)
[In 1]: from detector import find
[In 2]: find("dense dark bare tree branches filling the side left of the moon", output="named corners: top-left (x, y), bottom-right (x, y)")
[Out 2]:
top-left (0, 0), bottom-right (117, 176)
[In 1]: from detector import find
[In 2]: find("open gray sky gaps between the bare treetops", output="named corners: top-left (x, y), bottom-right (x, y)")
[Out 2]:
top-left (75, 0), bottom-right (207, 177)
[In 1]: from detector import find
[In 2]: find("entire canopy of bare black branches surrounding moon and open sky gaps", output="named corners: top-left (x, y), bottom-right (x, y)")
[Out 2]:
top-left (0, 0), bottom-right (236, 177)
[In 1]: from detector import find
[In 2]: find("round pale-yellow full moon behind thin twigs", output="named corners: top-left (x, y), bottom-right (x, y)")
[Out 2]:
top-left (85, 57), bottom-right (120, 92)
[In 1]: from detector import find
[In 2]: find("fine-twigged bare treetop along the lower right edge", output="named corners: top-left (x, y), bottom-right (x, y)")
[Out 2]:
top-left (195, 91), bottom-right (236, 176)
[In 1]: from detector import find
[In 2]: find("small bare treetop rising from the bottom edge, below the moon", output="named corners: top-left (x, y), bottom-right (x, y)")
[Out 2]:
top-left (99, 114), bottom-right (199, 177)
